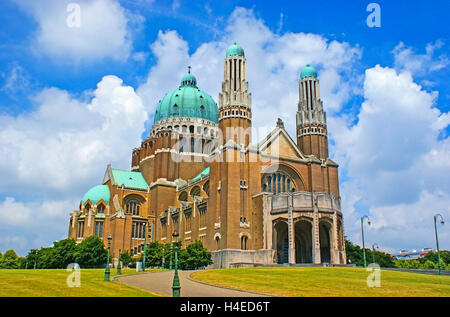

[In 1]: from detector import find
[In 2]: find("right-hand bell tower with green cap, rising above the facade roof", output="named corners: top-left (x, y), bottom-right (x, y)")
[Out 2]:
top-left (297, 65), bottom-right (328, 160)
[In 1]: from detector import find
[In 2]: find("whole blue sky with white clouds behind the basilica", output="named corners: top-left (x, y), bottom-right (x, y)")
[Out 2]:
top-left (0, 0), bottom-right (450, 255)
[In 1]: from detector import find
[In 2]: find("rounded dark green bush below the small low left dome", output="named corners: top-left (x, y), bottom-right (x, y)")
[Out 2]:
top-left (75, 236), bottom-right (108, 268)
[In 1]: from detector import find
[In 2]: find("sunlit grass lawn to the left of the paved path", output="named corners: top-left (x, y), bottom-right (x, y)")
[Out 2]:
top-left (0, 269), bottom-right (161, 297)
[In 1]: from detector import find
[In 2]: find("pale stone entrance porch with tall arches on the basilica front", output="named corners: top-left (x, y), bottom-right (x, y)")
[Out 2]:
top-left (261, 192), bottom-right (346, 264)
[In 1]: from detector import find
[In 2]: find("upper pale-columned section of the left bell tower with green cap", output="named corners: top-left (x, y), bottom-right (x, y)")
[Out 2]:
top-left (219, 43), bottom-right (252, 146)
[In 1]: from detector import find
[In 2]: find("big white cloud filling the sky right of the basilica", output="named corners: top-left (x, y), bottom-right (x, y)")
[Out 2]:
top-left (330, 65), bottom-right (450, 249)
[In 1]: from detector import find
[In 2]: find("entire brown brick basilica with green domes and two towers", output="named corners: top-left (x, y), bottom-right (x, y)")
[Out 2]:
top-left (69, 43), bottom-right (346, 268)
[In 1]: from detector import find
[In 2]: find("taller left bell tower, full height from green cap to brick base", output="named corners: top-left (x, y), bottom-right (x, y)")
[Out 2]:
top-left (208, 43), bottom-right (260, 252)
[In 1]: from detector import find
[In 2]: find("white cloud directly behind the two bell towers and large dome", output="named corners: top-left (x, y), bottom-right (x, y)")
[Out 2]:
top-left (137, 7), bottom-right (361, 142)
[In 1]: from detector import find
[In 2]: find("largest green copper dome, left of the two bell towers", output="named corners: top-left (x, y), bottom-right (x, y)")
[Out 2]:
top-left (154, 73), bottom-right (219, 123)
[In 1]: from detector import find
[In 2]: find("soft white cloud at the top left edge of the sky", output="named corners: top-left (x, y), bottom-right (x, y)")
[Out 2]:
top-left (16, 0), bottom-right (132, 62)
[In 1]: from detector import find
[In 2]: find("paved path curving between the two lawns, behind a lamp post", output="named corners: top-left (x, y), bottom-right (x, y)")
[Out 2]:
top-left (115, 271), bottom-right (267, 297)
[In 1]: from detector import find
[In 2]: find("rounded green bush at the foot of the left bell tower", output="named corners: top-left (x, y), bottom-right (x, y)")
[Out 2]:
top-left (178, 241), bottom-right (213, 270)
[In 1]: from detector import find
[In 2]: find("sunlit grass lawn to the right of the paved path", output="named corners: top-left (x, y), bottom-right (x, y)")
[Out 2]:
top-left (192, 267), bottom-right (450, 297)
